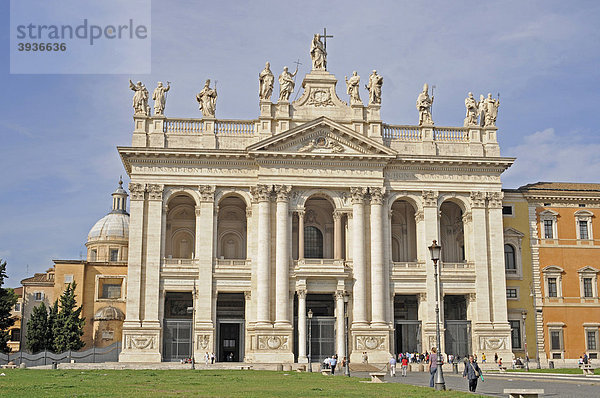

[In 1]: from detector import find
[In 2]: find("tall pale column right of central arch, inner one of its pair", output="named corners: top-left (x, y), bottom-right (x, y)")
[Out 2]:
top-left (350, 187), bottom-right (368, 327)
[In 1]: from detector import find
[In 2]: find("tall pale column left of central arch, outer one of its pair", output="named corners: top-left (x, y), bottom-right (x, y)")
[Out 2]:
top-left (253, 185), bottom-right (271, 325)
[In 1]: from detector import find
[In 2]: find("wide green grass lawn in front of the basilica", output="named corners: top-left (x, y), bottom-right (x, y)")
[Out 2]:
top-left (0, 369), bottom-right (473, 398)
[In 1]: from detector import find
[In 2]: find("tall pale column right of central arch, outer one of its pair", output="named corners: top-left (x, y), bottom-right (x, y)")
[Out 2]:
top-left (370, 188), bottom-right (386, 326)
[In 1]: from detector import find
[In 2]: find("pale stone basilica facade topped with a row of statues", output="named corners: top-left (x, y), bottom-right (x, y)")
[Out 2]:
top-left (118, 38), bottom-right (514, 363)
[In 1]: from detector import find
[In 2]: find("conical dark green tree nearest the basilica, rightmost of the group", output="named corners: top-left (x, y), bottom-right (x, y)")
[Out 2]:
top-left (52, 282), bottom-right (85, 353)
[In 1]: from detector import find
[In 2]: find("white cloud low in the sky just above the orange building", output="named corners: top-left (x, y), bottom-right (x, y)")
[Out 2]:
top-left (503, 128), bottom-right (600, 188)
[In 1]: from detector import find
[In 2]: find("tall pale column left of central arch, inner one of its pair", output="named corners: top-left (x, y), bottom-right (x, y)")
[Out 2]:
top-left (275, 185), bottom-right (291, 326)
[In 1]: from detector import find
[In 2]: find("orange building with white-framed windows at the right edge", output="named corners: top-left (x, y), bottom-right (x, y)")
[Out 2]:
top-left (519, 182), bottom-right (600, 367)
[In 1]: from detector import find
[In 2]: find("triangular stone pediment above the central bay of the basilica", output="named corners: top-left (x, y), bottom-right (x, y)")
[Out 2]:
top-left (247, 116), bottom-right (396, 157)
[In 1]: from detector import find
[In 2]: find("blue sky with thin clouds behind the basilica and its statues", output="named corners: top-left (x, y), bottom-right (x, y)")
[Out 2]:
top-left (0, 1), bottom-right (600, 286)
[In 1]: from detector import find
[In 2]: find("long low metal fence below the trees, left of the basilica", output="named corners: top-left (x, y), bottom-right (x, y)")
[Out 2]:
top-left (0, 342), bottom-right (121, 367)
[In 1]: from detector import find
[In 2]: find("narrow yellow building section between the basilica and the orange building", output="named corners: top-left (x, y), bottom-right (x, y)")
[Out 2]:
top-left (502, 189), bottom-right (537, 361)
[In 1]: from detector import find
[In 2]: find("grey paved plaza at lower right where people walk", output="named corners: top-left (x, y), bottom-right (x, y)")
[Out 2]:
top-left (352, 372), bottom-right (600, 398)
